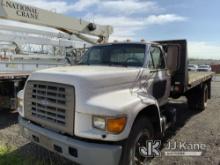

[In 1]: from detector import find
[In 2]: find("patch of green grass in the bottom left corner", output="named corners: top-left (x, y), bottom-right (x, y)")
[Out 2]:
top-left (0, 146), bottom-right (45, 165)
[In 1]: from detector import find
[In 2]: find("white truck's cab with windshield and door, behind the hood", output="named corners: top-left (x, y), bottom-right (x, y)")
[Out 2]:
top-left (79, 43), bottom-right (170, 105)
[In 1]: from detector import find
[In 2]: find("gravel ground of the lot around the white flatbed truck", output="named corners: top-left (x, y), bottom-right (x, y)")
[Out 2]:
top-left (0, 78), bottom-right (220, 165)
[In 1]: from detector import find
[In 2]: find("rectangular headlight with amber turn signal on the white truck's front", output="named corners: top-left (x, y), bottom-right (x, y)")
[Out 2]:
top-left (92, 116), bottom-right (127, 134)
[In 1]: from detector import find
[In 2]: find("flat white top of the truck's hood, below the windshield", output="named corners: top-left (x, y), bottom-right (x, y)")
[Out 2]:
top-left (30, 65), bottom-right (145, 89)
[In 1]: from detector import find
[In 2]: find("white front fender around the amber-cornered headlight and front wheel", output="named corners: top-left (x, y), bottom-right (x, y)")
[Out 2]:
top-left (75, 89), bottom-right (162, 141)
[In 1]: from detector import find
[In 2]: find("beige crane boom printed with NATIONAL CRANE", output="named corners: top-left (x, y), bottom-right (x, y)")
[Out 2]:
top-left (0, 0), bottom-right (113, 43)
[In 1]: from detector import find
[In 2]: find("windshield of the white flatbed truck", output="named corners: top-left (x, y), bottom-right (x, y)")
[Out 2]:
top-left (79, 44), bottom-right (146, 67)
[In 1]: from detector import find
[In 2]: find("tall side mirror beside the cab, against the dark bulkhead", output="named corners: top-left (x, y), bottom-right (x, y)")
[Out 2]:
top-left (166, 45), bottom-right (180, 74)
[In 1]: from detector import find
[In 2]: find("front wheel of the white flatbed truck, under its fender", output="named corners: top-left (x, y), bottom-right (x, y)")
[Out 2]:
top-left (130, 130), bottom-right (150, 165)
